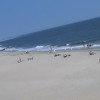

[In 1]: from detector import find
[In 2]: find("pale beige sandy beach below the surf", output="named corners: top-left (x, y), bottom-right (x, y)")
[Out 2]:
top-left (0, 50), bottom-right (100, 100)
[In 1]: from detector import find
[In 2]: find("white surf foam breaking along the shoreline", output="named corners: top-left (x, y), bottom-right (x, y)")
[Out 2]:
top-left (0, 44), bottom-right (100, 51)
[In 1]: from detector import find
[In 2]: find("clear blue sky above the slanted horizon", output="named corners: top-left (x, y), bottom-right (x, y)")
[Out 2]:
top-left (0, 0), bottom-right (100, 41)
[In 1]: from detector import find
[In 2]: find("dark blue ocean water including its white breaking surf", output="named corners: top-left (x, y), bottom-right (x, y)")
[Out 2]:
top-left (0, 17), bottom-right (100, 51)
